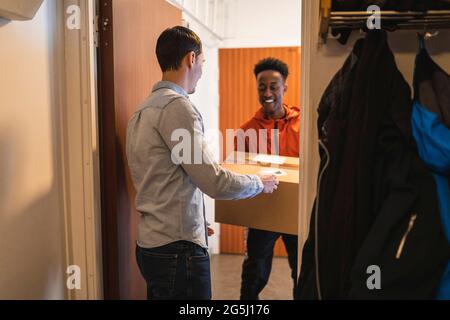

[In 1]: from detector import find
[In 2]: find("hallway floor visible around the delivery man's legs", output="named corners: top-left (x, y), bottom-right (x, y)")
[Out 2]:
top-left (211, 255), bottom-right (293, 300)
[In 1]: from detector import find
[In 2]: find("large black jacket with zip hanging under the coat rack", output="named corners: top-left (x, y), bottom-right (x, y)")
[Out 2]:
top-left (298, 31), bottom-right (449, 299)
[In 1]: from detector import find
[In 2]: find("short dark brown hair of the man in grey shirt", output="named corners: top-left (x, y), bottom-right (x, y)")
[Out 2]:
top-left (156, 26), bottom-right (203, 72)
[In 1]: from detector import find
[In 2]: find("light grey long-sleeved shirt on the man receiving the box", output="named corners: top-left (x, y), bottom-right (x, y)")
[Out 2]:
top-left (127, 81), bottom-right (264, 249)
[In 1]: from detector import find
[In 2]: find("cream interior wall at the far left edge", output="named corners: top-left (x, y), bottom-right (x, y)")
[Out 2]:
top-left (0, 0), bottom-right (65, 299)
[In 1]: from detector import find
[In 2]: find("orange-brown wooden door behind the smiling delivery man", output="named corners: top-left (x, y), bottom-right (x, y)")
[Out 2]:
top-left (219, 47), bottom-right (301, 257)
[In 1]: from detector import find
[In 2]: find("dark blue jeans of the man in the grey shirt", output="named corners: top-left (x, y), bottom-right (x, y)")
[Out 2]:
top-left (136, 241), bottom-right (211, 300)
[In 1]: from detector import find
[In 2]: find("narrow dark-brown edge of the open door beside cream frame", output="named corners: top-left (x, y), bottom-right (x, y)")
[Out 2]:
top-left (97, 0), bottom-right (120, 300)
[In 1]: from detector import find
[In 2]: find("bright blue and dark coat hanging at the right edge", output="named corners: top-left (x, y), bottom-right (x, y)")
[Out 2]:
top-left (412, 38), bottom-right (450, 300)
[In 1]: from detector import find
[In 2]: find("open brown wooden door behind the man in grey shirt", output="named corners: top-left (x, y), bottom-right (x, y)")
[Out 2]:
top-left (98, 0), bottom-right (182, 300)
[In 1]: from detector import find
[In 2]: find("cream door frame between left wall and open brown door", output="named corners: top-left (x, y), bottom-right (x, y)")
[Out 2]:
top-left (55, 0), bottom-right (103, 300)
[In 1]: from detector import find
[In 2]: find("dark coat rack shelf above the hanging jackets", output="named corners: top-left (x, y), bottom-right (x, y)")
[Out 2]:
top-left (320, 0), bottom-right (450, 43)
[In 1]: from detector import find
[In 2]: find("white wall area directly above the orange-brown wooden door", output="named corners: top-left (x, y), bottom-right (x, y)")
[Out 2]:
top-left (221, 0), bottom-right (302, 48)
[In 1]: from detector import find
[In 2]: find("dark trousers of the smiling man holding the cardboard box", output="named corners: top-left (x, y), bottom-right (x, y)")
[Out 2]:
top-left (241, 229), bottom-right (298, 300)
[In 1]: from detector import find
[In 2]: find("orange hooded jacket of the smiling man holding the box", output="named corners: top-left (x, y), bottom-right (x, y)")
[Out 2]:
top-left (235, 105), bottom-right (300, 158)
